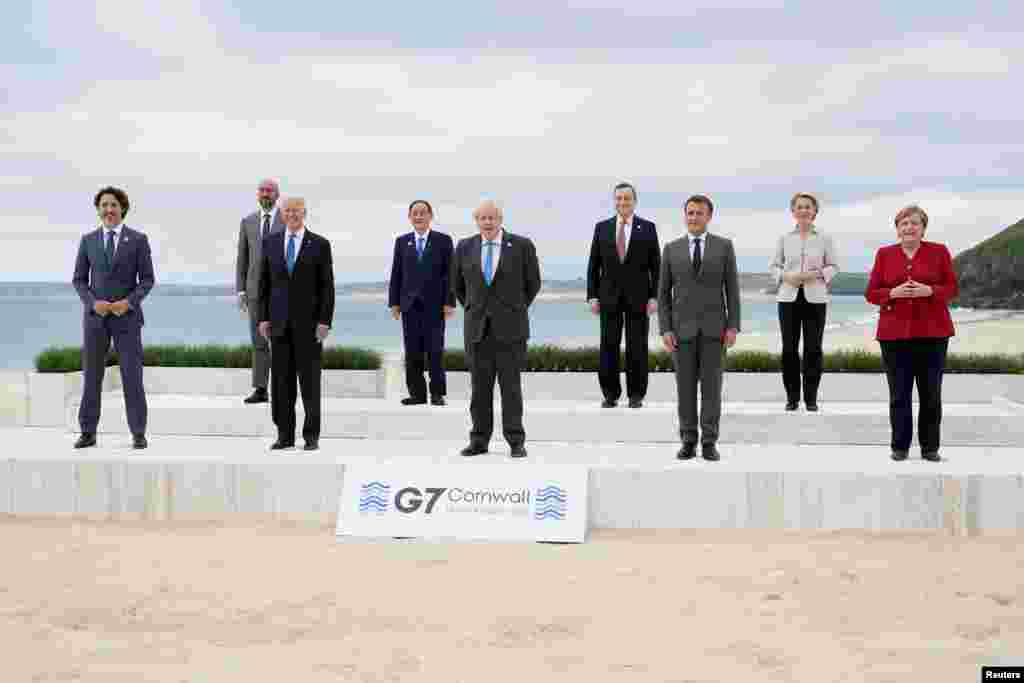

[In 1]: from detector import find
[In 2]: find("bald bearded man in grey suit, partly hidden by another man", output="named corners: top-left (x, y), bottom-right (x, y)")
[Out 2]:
top-left (234, 179), bottom-right (285, 403)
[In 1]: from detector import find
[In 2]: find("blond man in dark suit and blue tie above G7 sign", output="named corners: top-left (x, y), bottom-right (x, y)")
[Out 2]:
top-left (452, 202), bottom-right (541, 458)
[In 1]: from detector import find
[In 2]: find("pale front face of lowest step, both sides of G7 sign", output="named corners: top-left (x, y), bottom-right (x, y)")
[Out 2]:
top-left (0, 458), bottom-right (1024, 536)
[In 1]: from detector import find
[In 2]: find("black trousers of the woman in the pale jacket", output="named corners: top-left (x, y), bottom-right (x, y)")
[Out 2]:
top-left (778, 287), bottom-right (827, 403)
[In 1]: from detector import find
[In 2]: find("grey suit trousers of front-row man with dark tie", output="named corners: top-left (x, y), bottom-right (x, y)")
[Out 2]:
top-left (675, 334), bottom-right (725, 443)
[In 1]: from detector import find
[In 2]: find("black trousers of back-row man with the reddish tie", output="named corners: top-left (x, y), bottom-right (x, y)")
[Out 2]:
top-left (597, 299), bottom-right (650, 400)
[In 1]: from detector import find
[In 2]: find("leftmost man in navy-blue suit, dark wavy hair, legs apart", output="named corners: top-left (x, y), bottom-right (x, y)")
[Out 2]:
top-left (72, 187), bottom-right (154, 449)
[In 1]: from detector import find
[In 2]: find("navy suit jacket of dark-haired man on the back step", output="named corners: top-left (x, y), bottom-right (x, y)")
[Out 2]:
top-left (387, 229), bottom-right (456, 325)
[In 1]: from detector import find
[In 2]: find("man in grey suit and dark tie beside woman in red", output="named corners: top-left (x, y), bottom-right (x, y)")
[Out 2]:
top-left (657, 195), bottom-right (739, 461)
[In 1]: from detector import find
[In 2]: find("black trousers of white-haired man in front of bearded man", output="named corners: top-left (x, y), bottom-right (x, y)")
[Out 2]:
top-left (270, 326), bottom-right (324, 442)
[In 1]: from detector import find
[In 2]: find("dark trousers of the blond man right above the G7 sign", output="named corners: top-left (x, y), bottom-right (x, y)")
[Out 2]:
top-left (467, 321), bottom-right (526, 446)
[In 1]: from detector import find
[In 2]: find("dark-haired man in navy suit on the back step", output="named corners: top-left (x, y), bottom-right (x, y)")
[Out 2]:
top-left (388, 200), bottom-right (455, 405)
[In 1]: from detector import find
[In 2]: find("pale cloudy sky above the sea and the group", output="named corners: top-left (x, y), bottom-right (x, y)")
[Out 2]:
top-left (0, 0), bottom-right (1024, 283)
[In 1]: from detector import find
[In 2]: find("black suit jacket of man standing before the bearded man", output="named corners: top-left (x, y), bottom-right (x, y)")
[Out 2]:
top-left (259, 228), bottom-right (334, 339)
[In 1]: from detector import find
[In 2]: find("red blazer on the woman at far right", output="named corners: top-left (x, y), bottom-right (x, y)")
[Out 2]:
top-left (864, 241), bottom-right (959, 341)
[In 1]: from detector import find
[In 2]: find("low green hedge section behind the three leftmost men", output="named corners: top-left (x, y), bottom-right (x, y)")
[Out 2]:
top-left (36, 344), bottom-right (381, 373)
